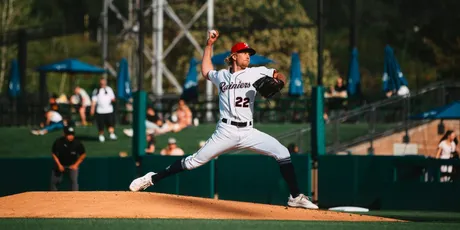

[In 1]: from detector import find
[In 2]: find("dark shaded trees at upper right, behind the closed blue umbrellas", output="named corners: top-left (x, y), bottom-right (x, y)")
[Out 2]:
top-left (302, 0), bottom-right (460, 94)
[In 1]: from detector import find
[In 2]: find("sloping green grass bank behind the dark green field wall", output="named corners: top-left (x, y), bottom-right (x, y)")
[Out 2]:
top-left (0, 123), bottom-right (392, 158)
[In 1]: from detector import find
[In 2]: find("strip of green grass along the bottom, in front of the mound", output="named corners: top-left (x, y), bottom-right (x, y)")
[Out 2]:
top-left (0, 216), bottom-right (460, 230)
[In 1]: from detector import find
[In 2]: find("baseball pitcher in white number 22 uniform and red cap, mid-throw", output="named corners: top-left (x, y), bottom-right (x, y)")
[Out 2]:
top-left (129, 30), bottom-right (318, 209)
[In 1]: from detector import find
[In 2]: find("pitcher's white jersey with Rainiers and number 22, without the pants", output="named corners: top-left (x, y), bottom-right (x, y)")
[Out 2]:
top-left (208, 66), bottom-right (275, 122)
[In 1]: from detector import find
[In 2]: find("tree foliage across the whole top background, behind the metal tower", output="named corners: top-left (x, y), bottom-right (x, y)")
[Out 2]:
top-left (0, 0), bottom-right (460, 97)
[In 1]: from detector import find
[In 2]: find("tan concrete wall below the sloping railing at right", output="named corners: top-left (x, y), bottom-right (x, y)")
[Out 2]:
top-left (349, 120), bottom-right (460, 157)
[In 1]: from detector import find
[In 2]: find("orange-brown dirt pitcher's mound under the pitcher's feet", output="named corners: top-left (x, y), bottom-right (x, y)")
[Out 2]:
top-left (0, 192), bottom-right (391, 221)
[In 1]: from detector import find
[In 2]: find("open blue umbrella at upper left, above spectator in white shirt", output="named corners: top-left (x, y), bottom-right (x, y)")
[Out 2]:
top-left (37, 58), bottom-right (106, 73)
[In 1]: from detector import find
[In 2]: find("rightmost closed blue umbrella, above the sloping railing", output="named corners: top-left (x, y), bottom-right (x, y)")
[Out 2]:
top-left (383, 45), bottom-right (408, 92)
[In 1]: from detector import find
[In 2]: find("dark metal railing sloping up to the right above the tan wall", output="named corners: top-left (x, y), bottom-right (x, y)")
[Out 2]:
top-left (326, 82), bottom-right (460, 154)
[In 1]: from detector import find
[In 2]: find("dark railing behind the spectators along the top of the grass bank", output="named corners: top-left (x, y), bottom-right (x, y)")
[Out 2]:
top-left (0, 96), bottom-right (310, 127)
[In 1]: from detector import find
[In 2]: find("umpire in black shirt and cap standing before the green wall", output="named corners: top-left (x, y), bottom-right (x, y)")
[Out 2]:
top-left (50, 126), bottom-right (86, 191)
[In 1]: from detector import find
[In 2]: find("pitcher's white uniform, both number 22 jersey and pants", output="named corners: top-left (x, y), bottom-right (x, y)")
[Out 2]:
top-left (182, 67), bottom-right (290, 170)
